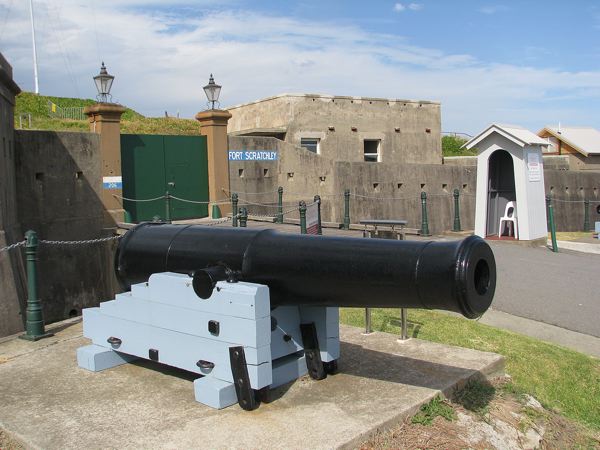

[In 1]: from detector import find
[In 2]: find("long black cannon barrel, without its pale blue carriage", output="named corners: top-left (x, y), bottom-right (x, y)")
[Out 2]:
top-left (115, 223), bottom-right (496, 318)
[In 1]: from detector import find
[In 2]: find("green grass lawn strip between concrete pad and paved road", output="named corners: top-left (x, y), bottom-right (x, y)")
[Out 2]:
top-left (340, 308), bottom-right (600, 430)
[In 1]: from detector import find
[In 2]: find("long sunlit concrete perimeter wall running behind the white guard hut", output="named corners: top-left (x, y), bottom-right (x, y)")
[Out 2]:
top-left (229, 137), bottom-right (600, 233)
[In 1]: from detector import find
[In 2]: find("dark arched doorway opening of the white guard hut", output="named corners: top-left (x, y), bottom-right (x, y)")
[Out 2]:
top-left (486, 150), bottom-right (517, 237)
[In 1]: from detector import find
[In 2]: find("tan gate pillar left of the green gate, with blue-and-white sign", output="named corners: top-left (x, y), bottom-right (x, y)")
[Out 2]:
top-left (83, 103), bottom-right (125, 228)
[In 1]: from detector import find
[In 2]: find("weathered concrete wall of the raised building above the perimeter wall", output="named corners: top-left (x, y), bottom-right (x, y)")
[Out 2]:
top-left (228, 94), bottom-right (442, 164)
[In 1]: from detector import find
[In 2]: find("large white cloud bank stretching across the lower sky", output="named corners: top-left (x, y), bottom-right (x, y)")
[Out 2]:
top-left (0, 0), bottom-right (600, 134)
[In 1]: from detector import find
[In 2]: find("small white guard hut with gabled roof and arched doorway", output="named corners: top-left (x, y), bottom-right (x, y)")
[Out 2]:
top-left (465, 124), bottom-right (548, 240)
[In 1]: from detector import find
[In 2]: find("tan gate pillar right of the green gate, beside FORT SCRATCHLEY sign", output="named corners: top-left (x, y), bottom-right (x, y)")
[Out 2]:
top-left (196, 109), bottom-right (231, 215)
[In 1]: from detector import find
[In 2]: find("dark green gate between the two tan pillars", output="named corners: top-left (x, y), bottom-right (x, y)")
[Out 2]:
top-left (121, 134), bottom-right (208, 222)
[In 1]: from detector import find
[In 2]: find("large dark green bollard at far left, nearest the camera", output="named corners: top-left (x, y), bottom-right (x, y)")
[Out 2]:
top-left (19, 230), bottom-right (52, 341)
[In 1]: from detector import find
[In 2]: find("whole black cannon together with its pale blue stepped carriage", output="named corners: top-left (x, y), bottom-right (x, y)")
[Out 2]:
top-left (77, 224), bottom-right (496, 410)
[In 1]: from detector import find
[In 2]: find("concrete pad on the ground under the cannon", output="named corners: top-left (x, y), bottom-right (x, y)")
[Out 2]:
top-left (0, 322), bottom-right (504, 449)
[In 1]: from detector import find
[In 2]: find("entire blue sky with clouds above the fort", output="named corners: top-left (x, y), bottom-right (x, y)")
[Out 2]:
top-left (0, 0), bottom-right (600, 134)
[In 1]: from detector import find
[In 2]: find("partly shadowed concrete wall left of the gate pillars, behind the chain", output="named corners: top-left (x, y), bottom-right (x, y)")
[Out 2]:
top-left (15, 131), bottom-right (114, 322)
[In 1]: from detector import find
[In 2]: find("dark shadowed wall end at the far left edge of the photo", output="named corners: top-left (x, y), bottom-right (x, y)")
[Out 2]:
top-left (0, 53), bottom-right (25, 337)
